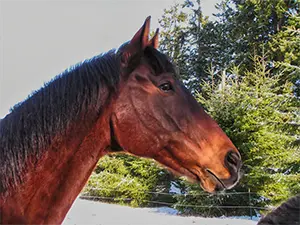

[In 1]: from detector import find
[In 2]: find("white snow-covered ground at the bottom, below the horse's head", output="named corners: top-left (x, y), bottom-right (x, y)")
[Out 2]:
top-left (63, 199), bottom-right (257, 225)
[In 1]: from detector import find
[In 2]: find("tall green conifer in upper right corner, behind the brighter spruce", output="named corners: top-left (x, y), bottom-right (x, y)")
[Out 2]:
top-left (214, 0), bottom-right (300, 96)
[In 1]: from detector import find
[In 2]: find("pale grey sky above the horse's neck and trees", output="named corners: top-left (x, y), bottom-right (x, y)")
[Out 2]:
top-left (0, 0), bottom-right (220, 118)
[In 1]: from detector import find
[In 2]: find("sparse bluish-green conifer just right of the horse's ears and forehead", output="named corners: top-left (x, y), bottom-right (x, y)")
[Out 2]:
top-left (159, 0), bottom-right (222, 91)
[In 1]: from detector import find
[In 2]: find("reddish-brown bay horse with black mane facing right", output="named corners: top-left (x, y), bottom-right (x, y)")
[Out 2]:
top-left (0, 17), bottom-right (241, 225)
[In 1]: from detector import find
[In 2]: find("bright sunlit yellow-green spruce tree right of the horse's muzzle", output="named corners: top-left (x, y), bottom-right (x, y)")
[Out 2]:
top-left (198, 56), bottom-right (300, 205)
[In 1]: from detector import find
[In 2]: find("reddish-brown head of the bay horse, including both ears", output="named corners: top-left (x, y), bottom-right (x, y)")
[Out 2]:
top-left (111, 19), bottom-right (241, 192)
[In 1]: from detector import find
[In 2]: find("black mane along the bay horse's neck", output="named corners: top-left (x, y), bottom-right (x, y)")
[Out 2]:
top-left (0, 50), bottom-right (120, 193)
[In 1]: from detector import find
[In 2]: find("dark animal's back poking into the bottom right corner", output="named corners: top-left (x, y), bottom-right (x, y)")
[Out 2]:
top-left (257, 195), bottom-right (300, 225)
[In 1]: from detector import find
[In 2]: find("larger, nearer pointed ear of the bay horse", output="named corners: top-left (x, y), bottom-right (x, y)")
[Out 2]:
top-left (122, 16), bottom-right (151, 64)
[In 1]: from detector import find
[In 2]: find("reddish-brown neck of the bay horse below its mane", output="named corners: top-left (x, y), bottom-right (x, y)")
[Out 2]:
top-left (0, 104), bottom-right (110, 224)
